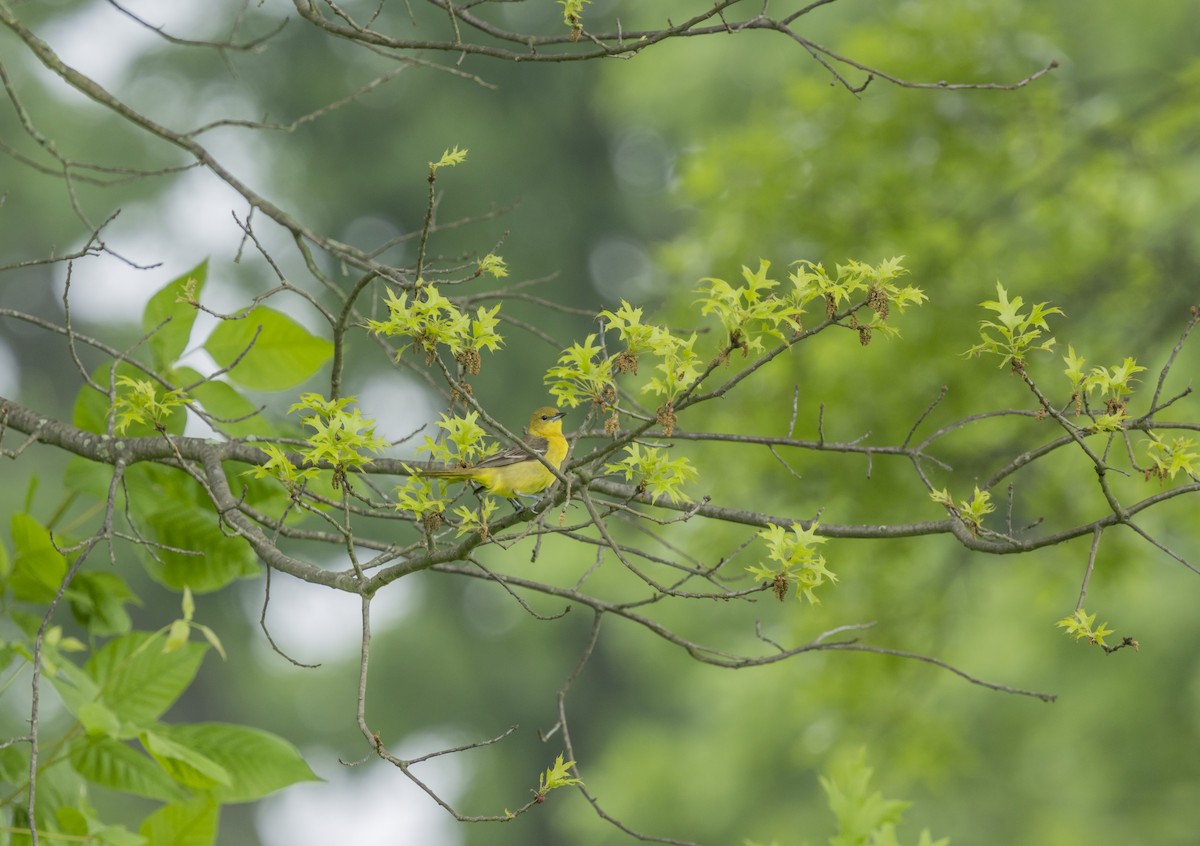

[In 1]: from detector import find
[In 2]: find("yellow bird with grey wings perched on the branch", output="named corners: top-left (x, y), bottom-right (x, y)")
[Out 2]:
top-left (414, 406), bottom-right (566, 504)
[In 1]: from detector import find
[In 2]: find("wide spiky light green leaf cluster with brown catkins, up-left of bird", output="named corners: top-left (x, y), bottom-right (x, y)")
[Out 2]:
top-left (366, 284), bottom-right (504, 373)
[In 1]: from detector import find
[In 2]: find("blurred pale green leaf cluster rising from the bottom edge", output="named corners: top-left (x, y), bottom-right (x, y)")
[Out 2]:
top-left (821, 750), bottom-right (950, 846)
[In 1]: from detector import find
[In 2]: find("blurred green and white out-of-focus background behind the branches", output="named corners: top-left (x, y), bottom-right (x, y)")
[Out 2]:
top-left (0, 0), bottom-right (1200, 846)
